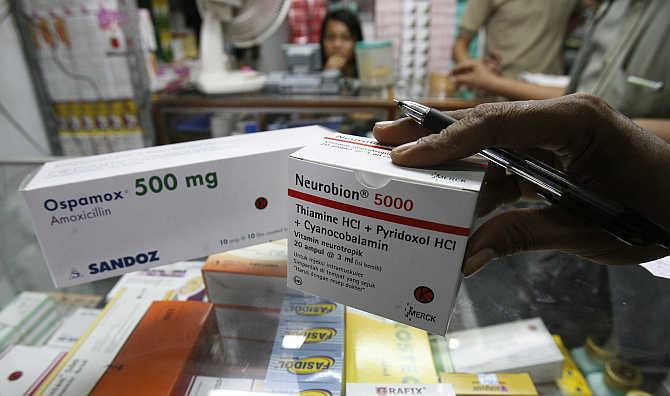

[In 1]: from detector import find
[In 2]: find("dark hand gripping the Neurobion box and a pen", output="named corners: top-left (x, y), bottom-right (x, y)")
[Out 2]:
top-left (373, 94), bottom-right (670, 276)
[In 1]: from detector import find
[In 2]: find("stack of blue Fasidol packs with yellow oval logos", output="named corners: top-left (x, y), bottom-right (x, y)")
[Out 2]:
top-left (263, 296), bottom-right (344, 396)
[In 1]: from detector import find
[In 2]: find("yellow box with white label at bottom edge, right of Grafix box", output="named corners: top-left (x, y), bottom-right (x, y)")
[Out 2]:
top-left (440, 373), bottom-right (537, 396)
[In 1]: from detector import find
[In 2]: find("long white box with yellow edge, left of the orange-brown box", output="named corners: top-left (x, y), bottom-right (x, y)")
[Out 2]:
top-left (37, 288), bottom-right (174, 396)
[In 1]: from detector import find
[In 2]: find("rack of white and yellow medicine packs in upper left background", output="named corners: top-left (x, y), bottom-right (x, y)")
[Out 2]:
top-left (22, 0), bottom-right (157, 155)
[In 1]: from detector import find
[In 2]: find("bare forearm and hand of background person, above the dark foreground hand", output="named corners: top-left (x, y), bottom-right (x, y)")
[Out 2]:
top-left (450, 62), bottom-right (565, 100)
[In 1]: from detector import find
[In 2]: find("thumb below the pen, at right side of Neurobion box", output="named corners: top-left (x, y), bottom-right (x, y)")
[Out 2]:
top-left (463, 206), bottom-right (613, 277)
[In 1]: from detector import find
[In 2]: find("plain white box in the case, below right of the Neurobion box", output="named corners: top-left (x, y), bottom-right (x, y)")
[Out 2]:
top-left (447, 318), bottom-right (564, 384)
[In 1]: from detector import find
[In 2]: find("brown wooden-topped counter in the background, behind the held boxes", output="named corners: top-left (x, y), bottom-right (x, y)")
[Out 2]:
top-left (152, 91), bottom-right (476, 144)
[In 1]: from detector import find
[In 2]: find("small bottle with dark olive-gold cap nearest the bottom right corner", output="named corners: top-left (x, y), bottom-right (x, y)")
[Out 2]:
top-left (586, 359), bottom-right (642, 396)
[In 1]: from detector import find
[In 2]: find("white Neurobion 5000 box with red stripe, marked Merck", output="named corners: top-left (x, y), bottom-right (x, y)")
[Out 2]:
top-left (287, 135), bottom-right (486, 334)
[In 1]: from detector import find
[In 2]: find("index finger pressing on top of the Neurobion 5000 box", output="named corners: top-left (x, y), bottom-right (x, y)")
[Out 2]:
top-left (391, 95), bottom-right (598, 167)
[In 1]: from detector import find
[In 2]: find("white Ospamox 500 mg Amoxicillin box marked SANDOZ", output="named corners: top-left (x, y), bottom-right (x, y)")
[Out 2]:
top-left (23, 126), bottom-right (330, 287)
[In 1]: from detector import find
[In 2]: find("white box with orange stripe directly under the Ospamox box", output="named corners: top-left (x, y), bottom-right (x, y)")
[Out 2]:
top-left (202, 239), bottom-right (289, 310)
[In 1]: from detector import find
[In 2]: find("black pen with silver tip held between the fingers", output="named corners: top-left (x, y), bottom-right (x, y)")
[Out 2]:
top-left (396, 100), bottom-right (670, 249)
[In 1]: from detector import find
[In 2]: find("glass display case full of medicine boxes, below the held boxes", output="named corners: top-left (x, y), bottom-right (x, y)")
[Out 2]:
top-left (0, 152), bottom-right (670, 396)
